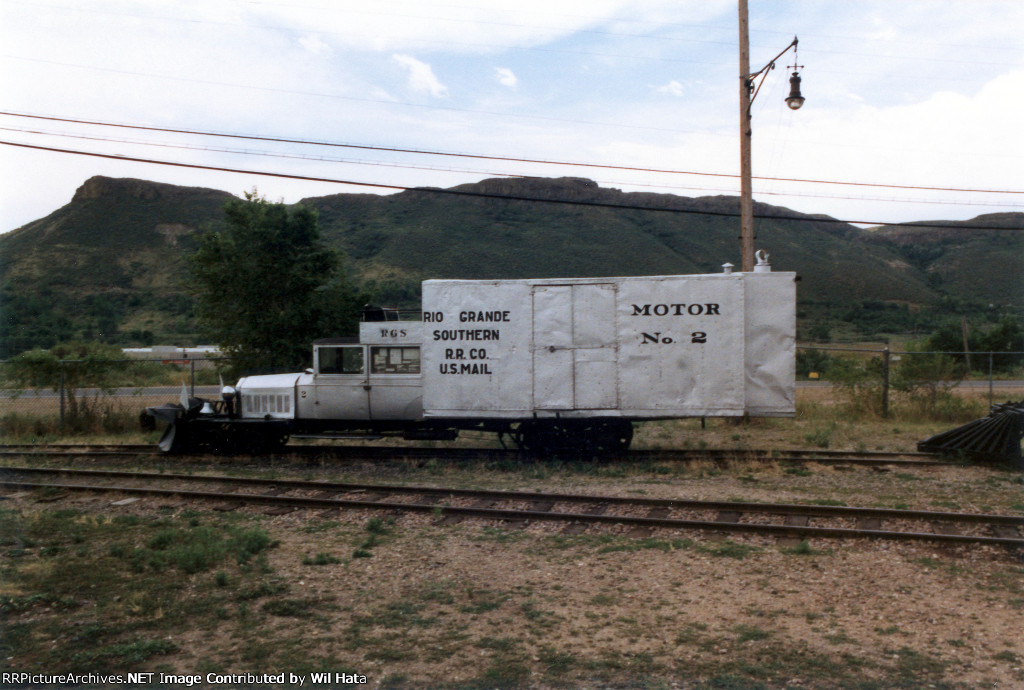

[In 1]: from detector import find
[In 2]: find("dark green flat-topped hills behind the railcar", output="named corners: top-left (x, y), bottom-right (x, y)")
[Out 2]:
top-left (0, 177), bottom-right (1024, 356)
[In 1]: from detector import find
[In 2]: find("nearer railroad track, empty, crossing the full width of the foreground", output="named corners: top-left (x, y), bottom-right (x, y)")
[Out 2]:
top-left (0, 467), bottom-right (1024, 553)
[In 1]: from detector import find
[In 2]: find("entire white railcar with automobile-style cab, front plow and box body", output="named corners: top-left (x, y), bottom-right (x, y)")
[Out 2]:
top-left (151, 257), bottom-right (796, 450)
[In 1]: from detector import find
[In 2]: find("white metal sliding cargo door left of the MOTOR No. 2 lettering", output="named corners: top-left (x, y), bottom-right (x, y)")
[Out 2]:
top-left (534, 284), bottom-right (618, 411)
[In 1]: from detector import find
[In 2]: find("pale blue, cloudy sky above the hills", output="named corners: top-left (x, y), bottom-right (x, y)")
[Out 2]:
top-left (0, 0), bottom-right (1024, 232)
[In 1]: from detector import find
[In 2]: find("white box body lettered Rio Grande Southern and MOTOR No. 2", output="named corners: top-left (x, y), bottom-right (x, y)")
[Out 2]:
top-left (422, 271), bottom-right (796, 419)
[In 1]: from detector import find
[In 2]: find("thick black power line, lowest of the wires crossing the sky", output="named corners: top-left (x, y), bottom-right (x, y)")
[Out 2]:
top-left (0, 140), bottom-right (1024, 231)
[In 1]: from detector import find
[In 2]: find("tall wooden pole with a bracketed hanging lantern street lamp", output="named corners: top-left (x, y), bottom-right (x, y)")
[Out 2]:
top-left (739, 0), bottom-right (804, 271)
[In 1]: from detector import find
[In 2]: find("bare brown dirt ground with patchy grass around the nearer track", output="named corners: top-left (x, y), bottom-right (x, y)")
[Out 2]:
top-left (6, 440), bottom-right (1024, 688)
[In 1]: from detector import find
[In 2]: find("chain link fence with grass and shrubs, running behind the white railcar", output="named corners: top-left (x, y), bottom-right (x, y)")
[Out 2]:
top-left (0, 346), bottom-right (1024, 440)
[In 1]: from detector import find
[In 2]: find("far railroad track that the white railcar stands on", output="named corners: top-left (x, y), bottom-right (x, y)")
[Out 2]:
top-left (0, 444), bottom-right (952, 466)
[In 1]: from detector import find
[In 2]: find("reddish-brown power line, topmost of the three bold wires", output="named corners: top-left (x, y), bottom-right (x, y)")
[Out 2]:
top-left (0, 111), bottom-right (1024, 196)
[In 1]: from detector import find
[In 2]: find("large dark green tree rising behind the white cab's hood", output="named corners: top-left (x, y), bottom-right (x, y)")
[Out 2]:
top-left (191, 190), bottom-right (359, 372)
